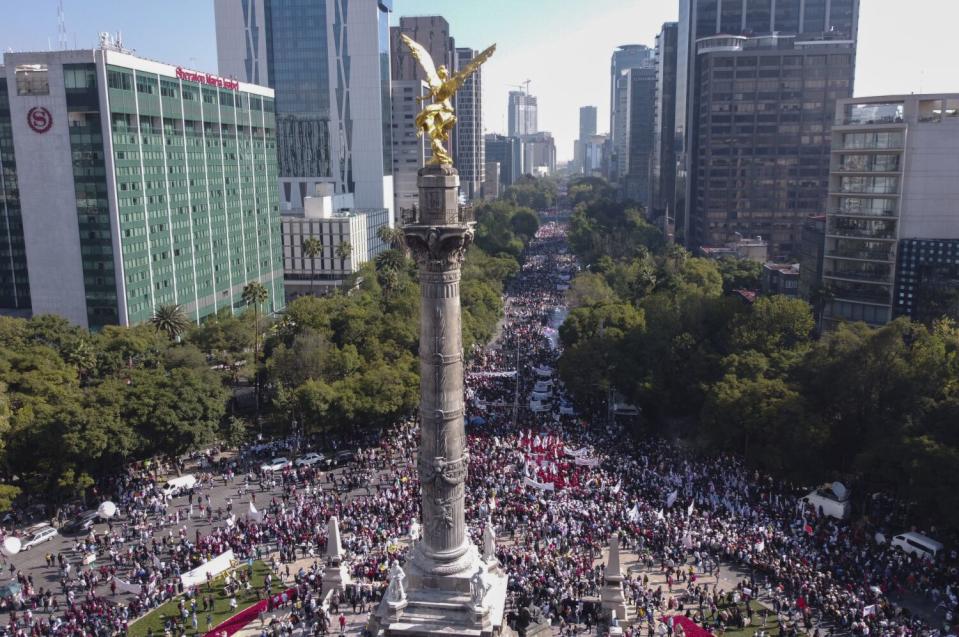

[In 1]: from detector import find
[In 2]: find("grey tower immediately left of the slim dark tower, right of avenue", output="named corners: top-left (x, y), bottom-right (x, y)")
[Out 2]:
top-left (622, 64), bottom-right (656, 209)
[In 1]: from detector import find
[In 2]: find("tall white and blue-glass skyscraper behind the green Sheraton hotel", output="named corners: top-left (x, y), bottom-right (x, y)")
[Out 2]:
top-left (214, 0), bottom-right (393, 216)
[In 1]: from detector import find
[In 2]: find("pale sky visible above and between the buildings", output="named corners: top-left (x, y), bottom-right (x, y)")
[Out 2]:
top-left (0, 0), bottom-right (959, 160)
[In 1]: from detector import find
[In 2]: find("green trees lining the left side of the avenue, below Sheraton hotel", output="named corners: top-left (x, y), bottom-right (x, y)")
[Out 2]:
top-left (0, 179), bottom-right (555, 511)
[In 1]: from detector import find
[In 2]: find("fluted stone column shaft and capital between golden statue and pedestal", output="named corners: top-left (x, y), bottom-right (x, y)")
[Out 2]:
top-left (403, 161), bottom-right (475, 587)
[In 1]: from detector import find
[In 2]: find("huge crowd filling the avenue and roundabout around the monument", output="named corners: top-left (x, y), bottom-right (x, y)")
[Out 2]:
top-left (0, 221), bottom-right (957, 637)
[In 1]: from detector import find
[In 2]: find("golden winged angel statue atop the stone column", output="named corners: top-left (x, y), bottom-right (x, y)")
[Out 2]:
top-left (400, 34), bottom-right (496, 164)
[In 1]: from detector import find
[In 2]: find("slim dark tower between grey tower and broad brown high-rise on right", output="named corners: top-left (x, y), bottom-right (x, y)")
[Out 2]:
top-left (646, 22), bottom-right (679, 219)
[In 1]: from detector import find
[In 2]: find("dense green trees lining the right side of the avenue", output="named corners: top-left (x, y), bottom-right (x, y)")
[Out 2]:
top-left (559, 174), bottom-right (959, 528)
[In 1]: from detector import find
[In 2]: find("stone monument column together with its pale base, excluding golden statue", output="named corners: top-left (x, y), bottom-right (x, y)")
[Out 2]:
top-left (369, 164), bottom-right (509, 637)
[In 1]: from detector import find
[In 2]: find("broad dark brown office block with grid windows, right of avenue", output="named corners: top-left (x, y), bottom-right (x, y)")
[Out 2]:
top-left (687, 36), bottom-right (855, 257)
